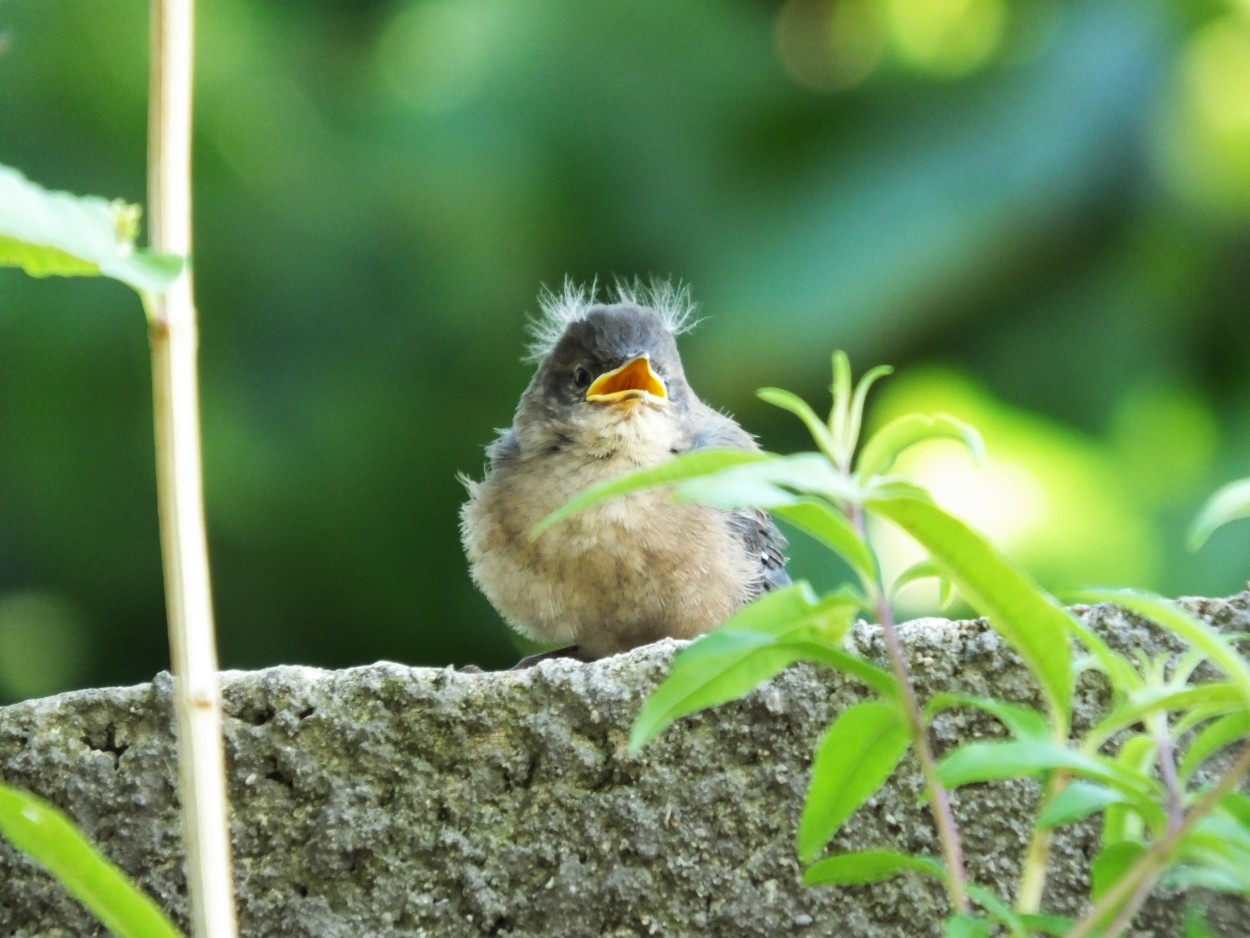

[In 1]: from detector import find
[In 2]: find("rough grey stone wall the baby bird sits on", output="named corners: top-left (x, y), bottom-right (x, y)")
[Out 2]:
top-left (0, 593), bottom-right (1250, 938)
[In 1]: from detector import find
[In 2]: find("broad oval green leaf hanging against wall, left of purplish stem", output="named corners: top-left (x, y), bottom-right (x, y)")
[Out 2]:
top-left (799, 700), bottom-right (911, 863)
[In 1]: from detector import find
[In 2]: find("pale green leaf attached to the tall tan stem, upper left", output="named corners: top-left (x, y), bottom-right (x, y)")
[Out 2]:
top-left (0, 165), bottom-right (184, 293)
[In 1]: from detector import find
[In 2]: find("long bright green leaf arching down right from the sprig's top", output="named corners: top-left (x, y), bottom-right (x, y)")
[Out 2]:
top-left (868, 497), bottom-right (1074, 738)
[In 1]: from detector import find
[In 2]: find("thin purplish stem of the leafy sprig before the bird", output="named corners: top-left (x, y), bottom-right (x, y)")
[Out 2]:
top-left (849, 504), bottom-right (969, 913)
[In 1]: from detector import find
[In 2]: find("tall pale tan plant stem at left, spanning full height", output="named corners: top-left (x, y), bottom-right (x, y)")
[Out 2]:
top-left (145, 0), bottom-right (235, 938)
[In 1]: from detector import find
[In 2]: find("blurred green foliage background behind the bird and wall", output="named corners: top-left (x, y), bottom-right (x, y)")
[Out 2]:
top-left (0, 0), bottom-right (1250, 700)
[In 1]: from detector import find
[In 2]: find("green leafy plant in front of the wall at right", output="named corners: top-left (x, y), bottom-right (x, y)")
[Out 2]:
top-left (534, 353), bottom-right (1250, 937)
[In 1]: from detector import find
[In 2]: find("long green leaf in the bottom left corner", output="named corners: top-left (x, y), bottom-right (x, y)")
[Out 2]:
top-left (0, 784), bottom-right (179, 938)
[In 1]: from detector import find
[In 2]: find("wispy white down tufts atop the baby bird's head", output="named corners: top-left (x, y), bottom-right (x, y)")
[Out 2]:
top-left (525, 279), bottom-right (699, 363)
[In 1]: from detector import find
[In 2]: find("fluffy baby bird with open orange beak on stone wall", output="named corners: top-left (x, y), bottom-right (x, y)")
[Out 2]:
top-left (460, 280), bottom-right (790, 662)
